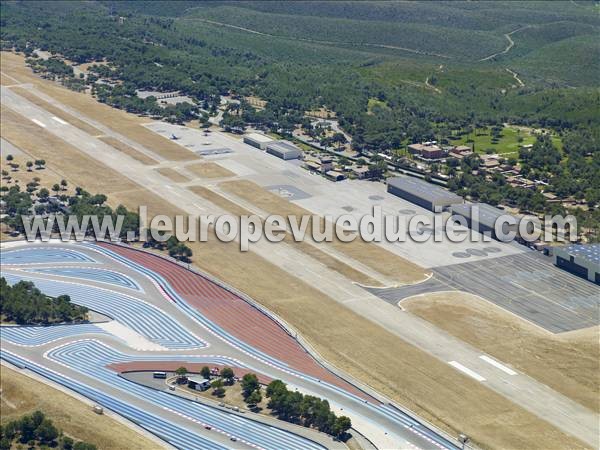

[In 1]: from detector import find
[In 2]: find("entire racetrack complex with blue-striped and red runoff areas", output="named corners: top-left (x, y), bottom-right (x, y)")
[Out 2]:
top-left (0, 241), bottom-right (457, 450)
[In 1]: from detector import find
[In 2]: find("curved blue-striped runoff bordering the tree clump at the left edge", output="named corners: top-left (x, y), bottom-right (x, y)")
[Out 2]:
top-left (2, 273), bottom-right (206, 350)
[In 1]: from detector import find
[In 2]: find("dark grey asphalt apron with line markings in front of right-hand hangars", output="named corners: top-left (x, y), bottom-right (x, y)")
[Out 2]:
top-left (371, 252), bottom-right (600, 333)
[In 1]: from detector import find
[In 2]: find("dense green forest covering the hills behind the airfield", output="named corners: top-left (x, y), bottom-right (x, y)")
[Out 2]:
top-left (0, 1), bottom-right (600, 237)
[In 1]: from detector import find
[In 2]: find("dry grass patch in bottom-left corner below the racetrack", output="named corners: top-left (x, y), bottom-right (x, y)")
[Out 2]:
top-left (1, 366), bottom-right (162, 450)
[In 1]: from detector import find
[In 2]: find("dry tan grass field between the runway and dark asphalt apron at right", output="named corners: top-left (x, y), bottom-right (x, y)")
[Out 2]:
top-left (402, 292), bottom-right (600, 412)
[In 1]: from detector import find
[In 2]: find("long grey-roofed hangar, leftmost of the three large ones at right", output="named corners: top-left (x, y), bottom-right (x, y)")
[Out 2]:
top-left (387, 176), bottom-right (464, 212)
